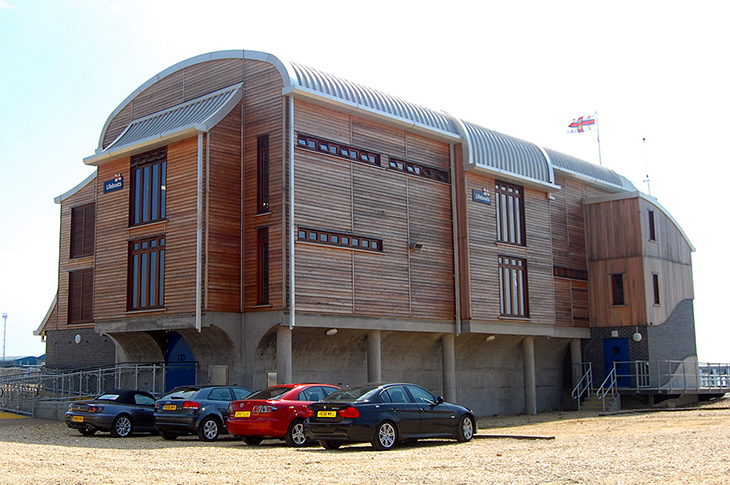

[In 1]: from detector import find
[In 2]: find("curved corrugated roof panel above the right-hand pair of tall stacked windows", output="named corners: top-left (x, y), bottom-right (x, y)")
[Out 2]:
top-left (462, 121), bottom-right (553, 184)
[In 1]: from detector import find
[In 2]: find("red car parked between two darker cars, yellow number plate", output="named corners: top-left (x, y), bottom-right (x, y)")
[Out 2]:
top-left (226, 384), bottom-right (339, 446)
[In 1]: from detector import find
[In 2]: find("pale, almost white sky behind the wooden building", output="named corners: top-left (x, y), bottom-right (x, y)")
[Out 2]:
top-left (0, 0), bottom-right (730, 362)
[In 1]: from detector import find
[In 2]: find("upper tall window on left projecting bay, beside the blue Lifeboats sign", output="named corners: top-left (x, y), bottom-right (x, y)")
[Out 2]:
top-left (129, 147), bottom-right (167, 226)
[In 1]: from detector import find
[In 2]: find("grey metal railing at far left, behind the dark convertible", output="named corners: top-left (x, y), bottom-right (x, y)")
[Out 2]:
top-left (0, 362), bottom-right (197, 416)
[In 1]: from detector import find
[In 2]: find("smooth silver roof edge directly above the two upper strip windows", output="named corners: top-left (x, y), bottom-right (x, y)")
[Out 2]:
top-left (282, 84), bottom-right (461, 143)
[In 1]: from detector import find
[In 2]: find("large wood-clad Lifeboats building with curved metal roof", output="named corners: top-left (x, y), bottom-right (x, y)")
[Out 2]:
top-left (36, 50), bottom-right (697, 416)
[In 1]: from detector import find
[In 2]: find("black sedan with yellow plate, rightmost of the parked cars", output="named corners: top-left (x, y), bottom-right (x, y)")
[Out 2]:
top-left (304, 383), bottom-right (476, 450)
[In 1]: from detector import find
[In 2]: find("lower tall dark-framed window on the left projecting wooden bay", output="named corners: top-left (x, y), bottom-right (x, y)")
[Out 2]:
top-left (127, 237), bottom-right (165, 310)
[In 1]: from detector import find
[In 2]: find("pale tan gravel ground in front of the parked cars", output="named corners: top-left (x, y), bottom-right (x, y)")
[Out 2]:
top-left (0, 400), bottom-right (730, 485)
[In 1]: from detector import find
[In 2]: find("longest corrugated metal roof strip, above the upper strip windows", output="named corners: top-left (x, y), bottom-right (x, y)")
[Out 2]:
top-left (291, 62), bottom-right (457, 134)
